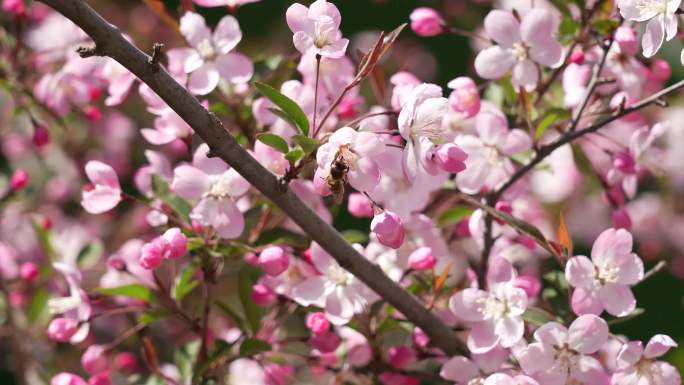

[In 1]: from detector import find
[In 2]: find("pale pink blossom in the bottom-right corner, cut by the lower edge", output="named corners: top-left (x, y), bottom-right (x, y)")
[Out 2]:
top-left (611, 334), bottom-right (681, 385)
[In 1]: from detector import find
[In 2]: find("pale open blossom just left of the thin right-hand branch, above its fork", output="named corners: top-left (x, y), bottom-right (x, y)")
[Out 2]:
top-left (454, 110), bottom-right (532, 194)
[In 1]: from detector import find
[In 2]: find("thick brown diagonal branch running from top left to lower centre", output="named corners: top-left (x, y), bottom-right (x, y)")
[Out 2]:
top-left (41, 0), bottom-right (467, 355)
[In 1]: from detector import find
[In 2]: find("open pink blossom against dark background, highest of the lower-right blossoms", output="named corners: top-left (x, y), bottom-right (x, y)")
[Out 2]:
top-left (565, 229), bottom-right (644, 317)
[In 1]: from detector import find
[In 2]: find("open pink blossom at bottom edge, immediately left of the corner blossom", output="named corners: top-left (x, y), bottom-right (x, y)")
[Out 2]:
top-left (518, 314), bottom-right (608, 385)
